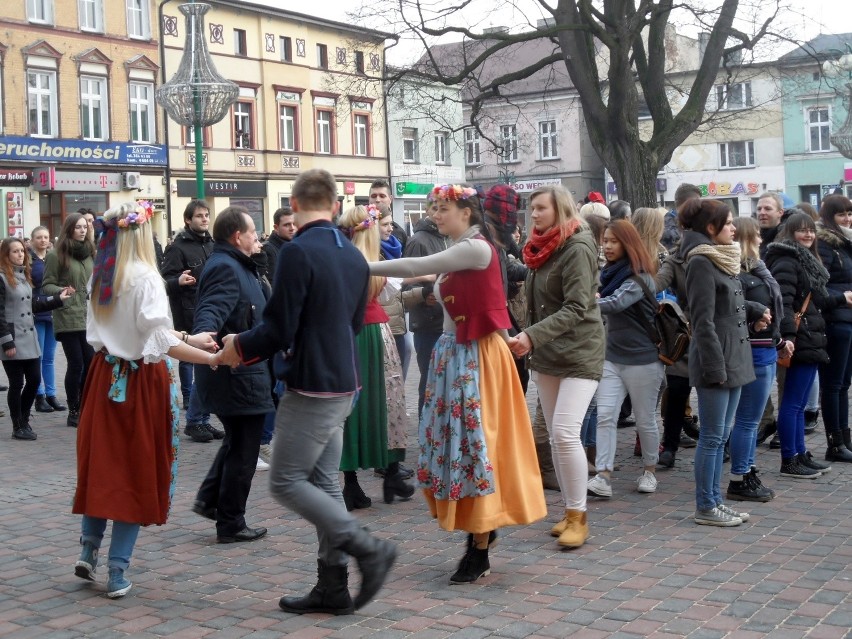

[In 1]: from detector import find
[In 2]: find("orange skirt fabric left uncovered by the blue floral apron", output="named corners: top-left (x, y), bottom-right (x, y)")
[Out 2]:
top-left (423, 333), bottom-right (547, 533)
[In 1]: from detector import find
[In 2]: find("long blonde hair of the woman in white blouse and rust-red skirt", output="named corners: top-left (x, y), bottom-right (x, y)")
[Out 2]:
top-left (89, 202), bottom-right (165, 319)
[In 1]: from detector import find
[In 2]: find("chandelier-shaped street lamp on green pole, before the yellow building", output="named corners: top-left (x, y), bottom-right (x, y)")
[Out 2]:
top-left (157, 2), bottom-right (240, 199)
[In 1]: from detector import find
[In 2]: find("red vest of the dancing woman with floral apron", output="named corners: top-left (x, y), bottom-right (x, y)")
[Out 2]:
top-left (440, 235), bottom-right (512, 344)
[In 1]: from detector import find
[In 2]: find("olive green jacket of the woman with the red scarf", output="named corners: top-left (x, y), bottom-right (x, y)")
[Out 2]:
top-left (524, 227), bottom-right (606, 380)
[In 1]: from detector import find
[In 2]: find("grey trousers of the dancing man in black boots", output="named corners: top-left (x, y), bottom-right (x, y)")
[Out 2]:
top-left (269, 390), bottom-right (358, 566)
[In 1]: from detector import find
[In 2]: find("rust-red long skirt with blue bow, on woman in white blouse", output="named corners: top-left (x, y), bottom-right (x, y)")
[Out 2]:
top-left (72, 353), bottom-right (180, 526)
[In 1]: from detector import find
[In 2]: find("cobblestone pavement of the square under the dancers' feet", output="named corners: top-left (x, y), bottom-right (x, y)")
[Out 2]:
top-left (0, 355), bottom-right (852, 639)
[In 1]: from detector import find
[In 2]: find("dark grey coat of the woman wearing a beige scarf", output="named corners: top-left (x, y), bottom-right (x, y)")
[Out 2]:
top-left (680, 231), bottom-right (766, 388)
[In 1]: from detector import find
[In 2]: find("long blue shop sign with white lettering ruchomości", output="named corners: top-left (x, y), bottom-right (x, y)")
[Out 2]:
top-left (0, 136), bottom-right (168, 167)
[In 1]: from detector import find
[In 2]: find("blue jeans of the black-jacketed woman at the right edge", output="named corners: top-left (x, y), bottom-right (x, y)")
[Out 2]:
top-left (819, 322), bottom-right (852, 433)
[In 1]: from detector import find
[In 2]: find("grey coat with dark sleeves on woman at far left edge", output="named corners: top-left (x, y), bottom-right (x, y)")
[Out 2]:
top-left (0, 267), bottom-right (62, 360)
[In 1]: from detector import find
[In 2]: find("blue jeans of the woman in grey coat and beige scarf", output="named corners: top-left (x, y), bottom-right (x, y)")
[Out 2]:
top-left (695, 386), bottom-right (742, 510)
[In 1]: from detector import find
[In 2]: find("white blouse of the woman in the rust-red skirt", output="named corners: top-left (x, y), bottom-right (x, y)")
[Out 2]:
top-left (86, 263), bottom-right (180, 364)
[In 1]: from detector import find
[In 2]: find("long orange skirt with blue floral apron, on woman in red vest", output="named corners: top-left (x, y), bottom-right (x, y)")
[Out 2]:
top-left (417, 333), bottom-right (547, 533)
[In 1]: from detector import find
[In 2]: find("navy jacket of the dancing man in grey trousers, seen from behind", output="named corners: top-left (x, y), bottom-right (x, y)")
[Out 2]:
top-left (234, 220), bottom-right (370, 394)
